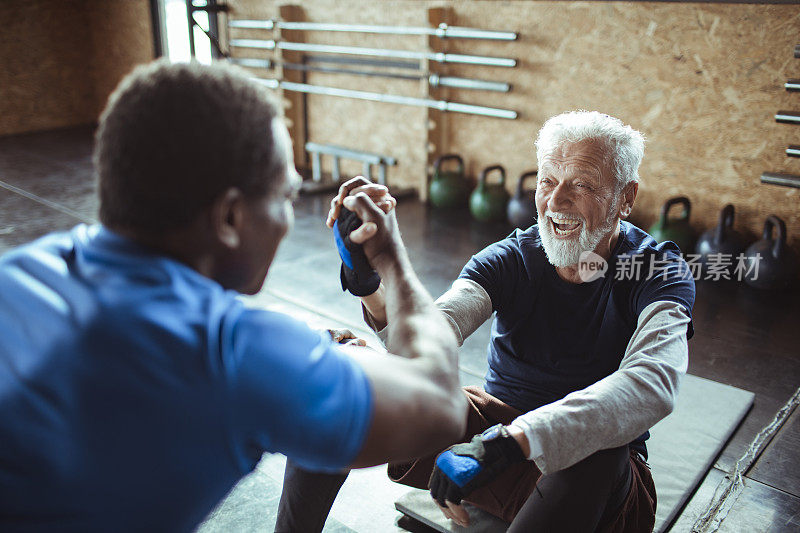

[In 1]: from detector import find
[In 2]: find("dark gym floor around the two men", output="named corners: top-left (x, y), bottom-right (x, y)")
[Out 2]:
top-left (0, 127), bottom-right (800, 532)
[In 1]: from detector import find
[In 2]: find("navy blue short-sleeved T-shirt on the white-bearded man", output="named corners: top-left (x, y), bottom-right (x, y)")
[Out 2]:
top-left (459, 221), bottom-right (695, 450)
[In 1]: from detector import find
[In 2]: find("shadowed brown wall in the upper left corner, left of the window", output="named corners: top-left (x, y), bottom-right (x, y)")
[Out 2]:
top-left (0, 0), bottom-right (153, 135)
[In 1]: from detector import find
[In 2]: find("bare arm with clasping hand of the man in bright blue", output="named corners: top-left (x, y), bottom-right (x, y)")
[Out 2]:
top-left (332, 188), bottom-right (467, 466)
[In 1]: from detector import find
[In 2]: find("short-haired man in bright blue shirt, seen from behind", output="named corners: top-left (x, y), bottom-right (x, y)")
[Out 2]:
top-left (0, 62), bottom-right (466, 532)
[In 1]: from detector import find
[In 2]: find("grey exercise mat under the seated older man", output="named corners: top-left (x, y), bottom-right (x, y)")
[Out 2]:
top-left (395, 375), bottom-right (755, 533)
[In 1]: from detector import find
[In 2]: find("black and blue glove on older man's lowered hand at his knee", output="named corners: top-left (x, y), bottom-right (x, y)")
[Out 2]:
top-left (428, 424), bottom-right (525, 507)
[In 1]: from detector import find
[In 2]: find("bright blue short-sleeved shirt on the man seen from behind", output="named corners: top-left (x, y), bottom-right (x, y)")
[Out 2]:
top-left (0, 225), bottom-right (372, 531)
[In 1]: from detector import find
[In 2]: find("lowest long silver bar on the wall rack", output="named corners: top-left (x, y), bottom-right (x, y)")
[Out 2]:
top-left (253, 78), bottom-right (518, 120)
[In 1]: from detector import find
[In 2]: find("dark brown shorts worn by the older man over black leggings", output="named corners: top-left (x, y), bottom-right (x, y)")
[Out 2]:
top-left (388, 387), bottom-right (656, 533)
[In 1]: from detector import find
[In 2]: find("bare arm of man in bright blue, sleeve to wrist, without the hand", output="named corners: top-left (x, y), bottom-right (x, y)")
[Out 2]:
top-left (346, 247), bottom-right (467, 466)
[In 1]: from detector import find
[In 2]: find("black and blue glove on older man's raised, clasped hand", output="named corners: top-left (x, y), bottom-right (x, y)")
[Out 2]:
top-left (333, 206), bottom-right (381, 296)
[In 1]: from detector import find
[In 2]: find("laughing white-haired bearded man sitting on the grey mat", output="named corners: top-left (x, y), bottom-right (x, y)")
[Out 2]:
top-left (278, 111), bottom-right (695, 532)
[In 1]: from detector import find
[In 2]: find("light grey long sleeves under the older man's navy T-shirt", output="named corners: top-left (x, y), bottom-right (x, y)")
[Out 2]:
top-left (365, 279), bottom-right (690, 474)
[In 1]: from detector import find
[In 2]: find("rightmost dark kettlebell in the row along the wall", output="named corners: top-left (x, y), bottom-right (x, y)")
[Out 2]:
top-left (744, 215), bottom-right (797, 289)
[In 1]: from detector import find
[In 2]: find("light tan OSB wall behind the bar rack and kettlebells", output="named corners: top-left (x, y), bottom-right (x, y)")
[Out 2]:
top-left (225, 0), bottom-right (800, 248)
